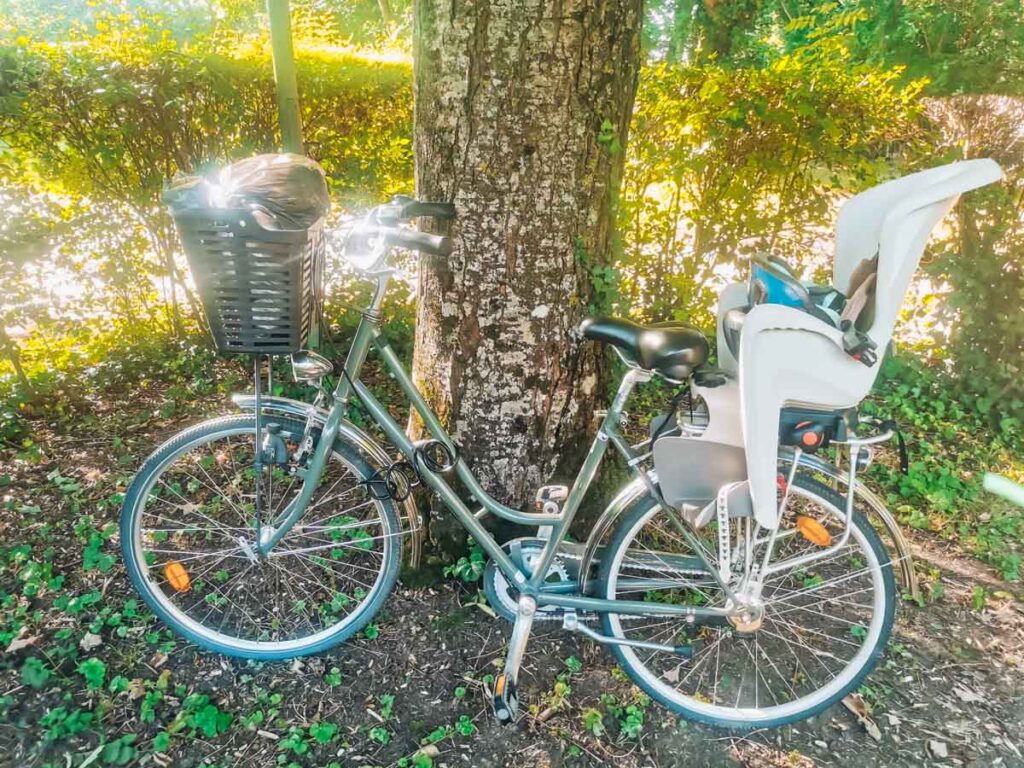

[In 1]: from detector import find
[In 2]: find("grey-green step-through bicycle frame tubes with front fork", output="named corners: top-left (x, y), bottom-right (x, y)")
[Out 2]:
top-left (257, 270), bottom-right (732, 620)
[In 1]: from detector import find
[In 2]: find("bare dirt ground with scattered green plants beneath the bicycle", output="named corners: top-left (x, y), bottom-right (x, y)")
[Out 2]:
top-left (0, 388), bottom-right (1024, 768)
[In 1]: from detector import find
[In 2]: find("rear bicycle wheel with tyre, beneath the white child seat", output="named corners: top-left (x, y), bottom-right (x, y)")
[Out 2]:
top-left (599, 477), bottom-right (896, 730)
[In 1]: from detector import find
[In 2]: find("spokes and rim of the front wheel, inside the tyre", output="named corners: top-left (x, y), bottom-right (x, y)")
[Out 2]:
top-left (126, 422), bottom-right (402, 645)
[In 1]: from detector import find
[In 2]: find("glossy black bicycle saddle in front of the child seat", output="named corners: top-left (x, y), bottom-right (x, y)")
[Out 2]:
top-left (580, 317), bottom-right (708, 381)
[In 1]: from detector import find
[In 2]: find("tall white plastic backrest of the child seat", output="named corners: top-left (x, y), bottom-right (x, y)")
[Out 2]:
top-left (833, 159), bottom-right (1002, 349)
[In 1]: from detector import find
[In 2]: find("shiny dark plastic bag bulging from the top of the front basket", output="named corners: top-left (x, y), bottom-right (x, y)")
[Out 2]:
top-left (164, 154), bottom-right (331, 229)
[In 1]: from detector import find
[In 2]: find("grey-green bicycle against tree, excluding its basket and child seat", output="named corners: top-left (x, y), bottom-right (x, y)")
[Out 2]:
top-left (121, 199), bottom-right (896, 729)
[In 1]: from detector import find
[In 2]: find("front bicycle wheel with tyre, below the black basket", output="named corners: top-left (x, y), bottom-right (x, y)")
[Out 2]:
top-left (121, 415), bottom-right (401, 659)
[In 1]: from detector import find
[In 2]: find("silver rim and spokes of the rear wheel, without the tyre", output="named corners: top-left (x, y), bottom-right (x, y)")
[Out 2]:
top-left (607, 485), bottom-right (888, 725)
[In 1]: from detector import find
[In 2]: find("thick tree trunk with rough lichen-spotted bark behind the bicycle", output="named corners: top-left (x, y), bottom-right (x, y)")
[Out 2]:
top-left (413, 0), bottom-right (641, 514)
